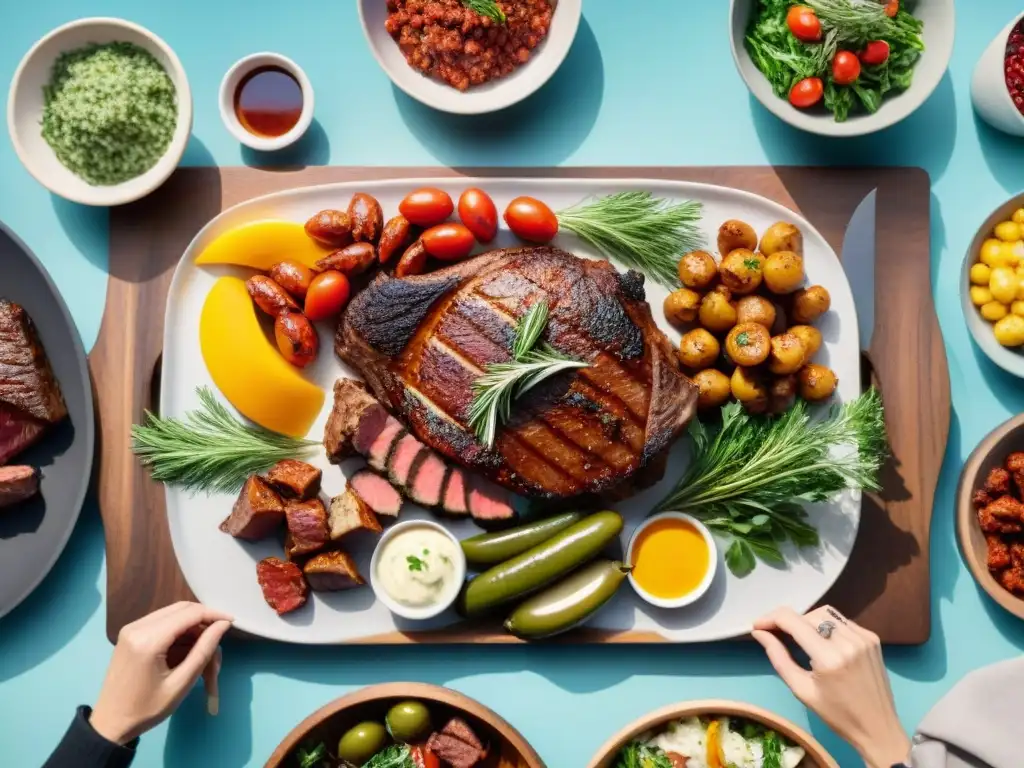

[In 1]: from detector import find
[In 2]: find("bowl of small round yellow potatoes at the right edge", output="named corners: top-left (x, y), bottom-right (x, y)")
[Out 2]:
top-left (962, 195), bottom-right (1024, 378)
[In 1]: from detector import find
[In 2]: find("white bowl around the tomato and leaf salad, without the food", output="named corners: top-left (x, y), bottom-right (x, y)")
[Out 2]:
top-left (729, 0), bottom-right (954, 136)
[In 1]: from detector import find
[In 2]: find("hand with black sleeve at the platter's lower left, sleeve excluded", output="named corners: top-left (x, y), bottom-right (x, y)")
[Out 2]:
top-left (89, 602), bottom-right (232, 744)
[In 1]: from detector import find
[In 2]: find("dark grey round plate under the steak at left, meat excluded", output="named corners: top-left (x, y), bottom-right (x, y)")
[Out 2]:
top-left (0, 222), bottom-right (96, 616)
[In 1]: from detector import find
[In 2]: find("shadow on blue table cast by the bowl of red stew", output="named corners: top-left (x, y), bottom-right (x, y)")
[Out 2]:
top-left (392, 17), bottom-right (604, 166)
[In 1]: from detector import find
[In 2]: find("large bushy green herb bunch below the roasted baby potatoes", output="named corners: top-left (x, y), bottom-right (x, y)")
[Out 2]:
top-left (657, 389), bottom-right (888, 577)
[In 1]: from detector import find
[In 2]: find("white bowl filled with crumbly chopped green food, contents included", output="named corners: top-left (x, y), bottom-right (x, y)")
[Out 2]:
top-left (7, 18), bottom-right (191, 206)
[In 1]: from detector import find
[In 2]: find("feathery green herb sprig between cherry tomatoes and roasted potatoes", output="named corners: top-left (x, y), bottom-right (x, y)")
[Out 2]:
top-left (556, 191), bottom-right (705, 288)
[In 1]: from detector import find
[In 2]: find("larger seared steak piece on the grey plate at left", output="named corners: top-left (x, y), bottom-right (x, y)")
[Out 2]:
top-left (0, 299), bottom-right (68, 464)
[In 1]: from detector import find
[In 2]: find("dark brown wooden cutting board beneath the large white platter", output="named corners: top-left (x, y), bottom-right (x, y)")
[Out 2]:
top-left (90, 167), bottom-right (950, 644)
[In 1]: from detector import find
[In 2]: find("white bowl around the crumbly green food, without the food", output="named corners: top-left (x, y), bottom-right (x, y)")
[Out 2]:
top-left (7, 18), bottom-right (193, 206)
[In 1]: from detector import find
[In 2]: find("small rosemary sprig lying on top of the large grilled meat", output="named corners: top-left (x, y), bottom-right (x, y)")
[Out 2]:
top-left (469, 301), bottom-right (590, 447)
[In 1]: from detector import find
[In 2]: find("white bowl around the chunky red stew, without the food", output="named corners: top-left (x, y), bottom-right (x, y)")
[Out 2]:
top-left (358, 0), bottom-right (583, 115)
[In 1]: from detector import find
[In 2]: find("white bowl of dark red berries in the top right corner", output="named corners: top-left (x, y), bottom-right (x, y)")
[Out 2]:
top-left (971, 13), bottom-right (1024, 136)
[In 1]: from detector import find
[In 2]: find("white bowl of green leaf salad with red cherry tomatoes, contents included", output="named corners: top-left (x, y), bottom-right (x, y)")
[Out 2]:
top-left (730, 0), bottom-right (954, 136)
